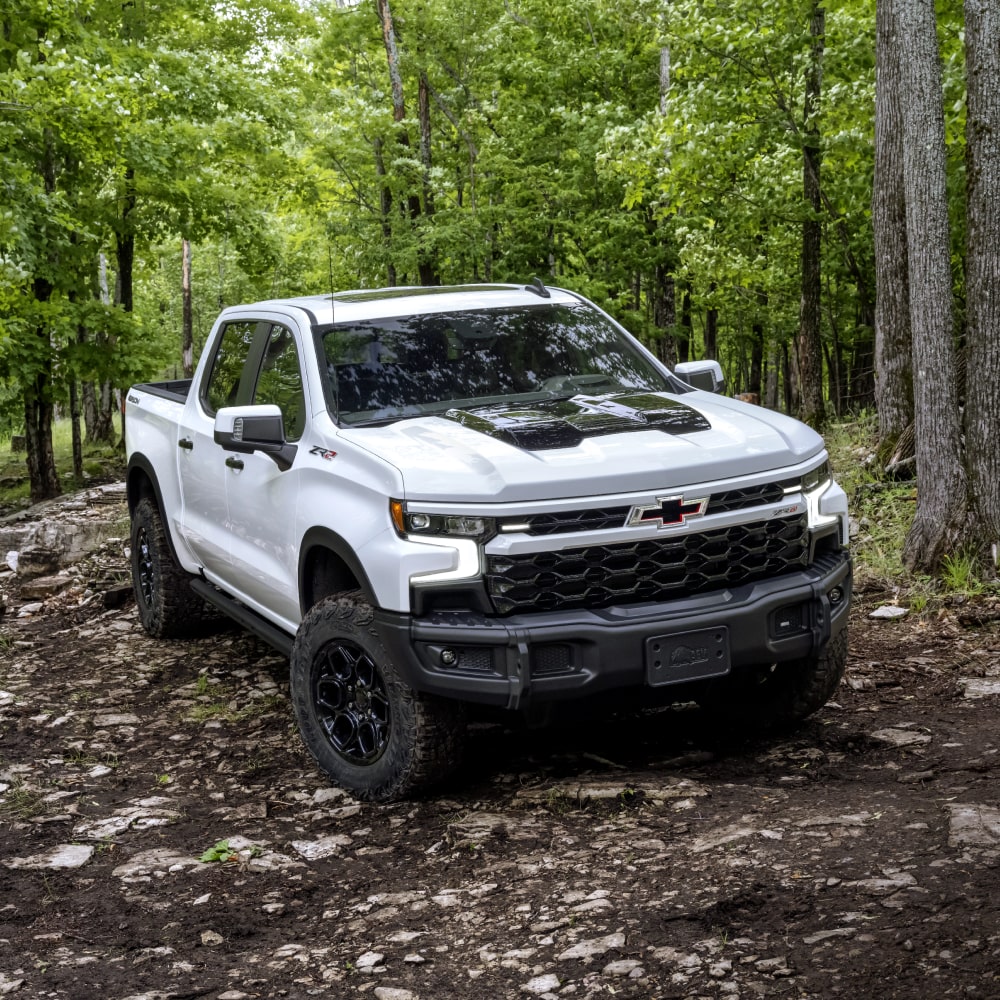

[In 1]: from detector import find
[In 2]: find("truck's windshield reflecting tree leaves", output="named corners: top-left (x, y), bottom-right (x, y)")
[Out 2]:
top-left (322, 304), bottom-right (674, 426)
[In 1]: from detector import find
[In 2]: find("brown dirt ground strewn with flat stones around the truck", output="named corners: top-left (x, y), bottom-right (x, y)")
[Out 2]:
top-left (0, 488), bottom-right (1000, 1000)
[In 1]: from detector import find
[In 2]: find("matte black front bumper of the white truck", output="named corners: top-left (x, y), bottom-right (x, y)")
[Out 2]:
top-left (376, 551), bottom-right (852, 709)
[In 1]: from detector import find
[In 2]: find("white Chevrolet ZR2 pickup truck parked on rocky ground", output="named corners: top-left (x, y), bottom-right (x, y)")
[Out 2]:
top-left (126, 279), bottom-right (851, 800)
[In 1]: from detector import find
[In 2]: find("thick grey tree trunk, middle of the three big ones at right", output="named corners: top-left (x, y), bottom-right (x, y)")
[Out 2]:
top-left (896, 0), bottom-right (968, 572)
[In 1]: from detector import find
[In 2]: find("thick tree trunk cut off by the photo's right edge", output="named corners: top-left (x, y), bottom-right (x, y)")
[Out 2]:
top-left (965, 0), bottom-right (1000, 563)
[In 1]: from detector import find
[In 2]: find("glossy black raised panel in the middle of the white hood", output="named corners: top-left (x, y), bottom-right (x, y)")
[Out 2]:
top-left (442, 392), bottom-right (712, 451)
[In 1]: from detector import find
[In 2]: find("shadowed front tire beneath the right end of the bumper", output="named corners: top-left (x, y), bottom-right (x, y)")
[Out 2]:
top-left (698, 629), bottom-right (847, 732)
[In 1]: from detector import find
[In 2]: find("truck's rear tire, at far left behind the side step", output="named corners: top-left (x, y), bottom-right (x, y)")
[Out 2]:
top-left (129, 497), bottom-right (208, 639)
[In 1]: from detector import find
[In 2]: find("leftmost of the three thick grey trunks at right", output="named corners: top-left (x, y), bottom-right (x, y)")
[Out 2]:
top-left (872, 0), bottom-right (913, 458)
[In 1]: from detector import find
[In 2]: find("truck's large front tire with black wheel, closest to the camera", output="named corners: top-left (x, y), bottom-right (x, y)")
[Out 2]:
top-left (290, 592), bottom-right (465, 802)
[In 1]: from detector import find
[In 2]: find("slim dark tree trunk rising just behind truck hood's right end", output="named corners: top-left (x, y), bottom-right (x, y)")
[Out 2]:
top-left (796, 0), bottom-right (826, 428)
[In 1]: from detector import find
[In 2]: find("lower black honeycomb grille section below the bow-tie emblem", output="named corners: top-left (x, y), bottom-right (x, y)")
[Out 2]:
top-left (486, 514), bottom-right (809, 615)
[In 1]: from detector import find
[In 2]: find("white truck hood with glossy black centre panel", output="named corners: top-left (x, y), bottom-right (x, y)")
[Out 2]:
top-left (340, 391), bottom-right (823, 503)
